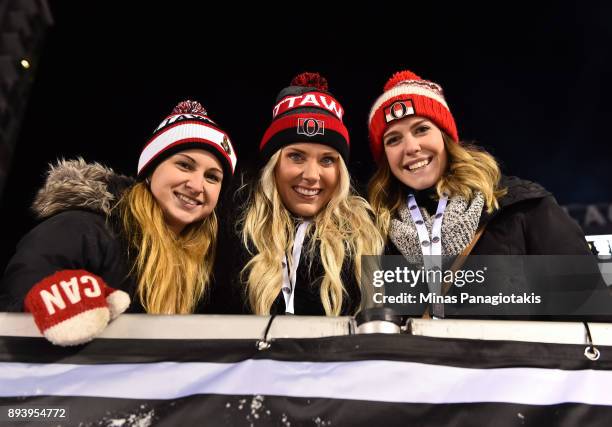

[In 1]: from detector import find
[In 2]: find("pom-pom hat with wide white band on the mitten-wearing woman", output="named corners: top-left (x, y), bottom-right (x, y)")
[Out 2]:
top-left (138, 100), bottom-right (238, 183)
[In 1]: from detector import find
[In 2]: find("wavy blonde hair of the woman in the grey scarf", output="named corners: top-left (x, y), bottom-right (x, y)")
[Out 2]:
top-left (368, 132), bottom-right (507, 238)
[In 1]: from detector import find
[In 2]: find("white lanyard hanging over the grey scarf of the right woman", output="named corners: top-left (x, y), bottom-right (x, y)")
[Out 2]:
top-left (408, 193), bottom-right (448, 318)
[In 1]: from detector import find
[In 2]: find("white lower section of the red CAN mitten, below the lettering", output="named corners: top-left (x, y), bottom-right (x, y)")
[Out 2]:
top-left (43, 307), bottom-right (110, 346)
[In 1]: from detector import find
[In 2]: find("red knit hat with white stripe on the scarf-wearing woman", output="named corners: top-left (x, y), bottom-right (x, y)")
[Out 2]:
top-left (368, 71), bottom-right (459, 162)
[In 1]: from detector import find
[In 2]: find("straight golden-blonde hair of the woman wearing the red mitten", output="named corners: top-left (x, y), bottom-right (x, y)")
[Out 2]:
top-left (116, 182), bottom-right (217, 314)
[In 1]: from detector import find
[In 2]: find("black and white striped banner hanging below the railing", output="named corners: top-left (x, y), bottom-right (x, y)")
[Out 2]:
top-left (0, 335), bottom-right (612, 427)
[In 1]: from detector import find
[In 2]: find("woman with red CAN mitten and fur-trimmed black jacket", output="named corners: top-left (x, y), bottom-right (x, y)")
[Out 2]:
top-left (1, 101), bottom-right (236, 345)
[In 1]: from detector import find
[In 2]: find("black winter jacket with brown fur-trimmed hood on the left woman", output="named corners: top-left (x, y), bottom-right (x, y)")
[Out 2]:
top-left (0, 159), bottom-right (214, 313)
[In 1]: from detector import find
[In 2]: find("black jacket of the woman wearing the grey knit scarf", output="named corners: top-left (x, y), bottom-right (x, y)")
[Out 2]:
top-left (385, 177), bottom-right (612, 320)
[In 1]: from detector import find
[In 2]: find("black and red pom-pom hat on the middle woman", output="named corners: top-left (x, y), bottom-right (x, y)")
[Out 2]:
top-left (259, 73), bottom-right (350, 162)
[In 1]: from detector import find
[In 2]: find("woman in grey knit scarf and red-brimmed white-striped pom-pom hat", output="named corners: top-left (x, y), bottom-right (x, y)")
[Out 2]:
top-left (368, 71), bottom-right (602, 314)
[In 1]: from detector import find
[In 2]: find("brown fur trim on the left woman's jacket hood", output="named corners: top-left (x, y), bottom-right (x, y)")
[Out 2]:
top-left (32, 157), bottom-right (134, 219)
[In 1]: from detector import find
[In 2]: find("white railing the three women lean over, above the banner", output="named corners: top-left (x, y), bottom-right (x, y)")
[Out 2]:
top-left (0, 313), bottom-right (612, 345)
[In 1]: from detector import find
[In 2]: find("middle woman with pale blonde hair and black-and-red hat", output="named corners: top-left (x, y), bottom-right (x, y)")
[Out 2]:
top-left (240, 73), bottom-right (383, 316)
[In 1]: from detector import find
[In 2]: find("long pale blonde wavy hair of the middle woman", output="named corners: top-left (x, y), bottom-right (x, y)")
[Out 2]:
top-left (239, 149), bottom-right (384, 316)
